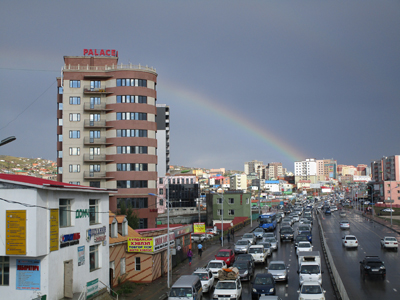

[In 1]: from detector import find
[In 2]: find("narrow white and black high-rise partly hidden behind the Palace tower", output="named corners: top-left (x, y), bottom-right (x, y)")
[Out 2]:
top-left (156, 104), bottom-right (169, 177)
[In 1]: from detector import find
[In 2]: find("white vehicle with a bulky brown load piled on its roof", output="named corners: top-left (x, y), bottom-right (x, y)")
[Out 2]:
top-left (212, 268), bottom-right (243, 300)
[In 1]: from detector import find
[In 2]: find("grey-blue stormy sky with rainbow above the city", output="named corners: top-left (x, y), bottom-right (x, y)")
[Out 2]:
top-left (0, 0), bottom-right (400, 171)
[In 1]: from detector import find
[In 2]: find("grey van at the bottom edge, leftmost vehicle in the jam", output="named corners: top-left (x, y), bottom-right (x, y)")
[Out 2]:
top-left (168, 275), bottom-right (203, 300)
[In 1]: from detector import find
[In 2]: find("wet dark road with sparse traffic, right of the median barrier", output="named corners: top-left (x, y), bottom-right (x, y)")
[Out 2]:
top-left (321, 207), bottom-right (400, 300)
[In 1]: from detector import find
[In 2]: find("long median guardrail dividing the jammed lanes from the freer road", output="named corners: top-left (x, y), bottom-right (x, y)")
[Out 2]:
top-left (317, 209), bottom-right (350, 300)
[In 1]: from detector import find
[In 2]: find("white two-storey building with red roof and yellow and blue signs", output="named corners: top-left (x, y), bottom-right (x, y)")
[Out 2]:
top-left (0, 174), bottom-right (109, 300)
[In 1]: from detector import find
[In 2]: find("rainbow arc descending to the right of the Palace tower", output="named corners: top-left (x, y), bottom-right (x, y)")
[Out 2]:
top-left (159, 82), bottom-right (307, 161)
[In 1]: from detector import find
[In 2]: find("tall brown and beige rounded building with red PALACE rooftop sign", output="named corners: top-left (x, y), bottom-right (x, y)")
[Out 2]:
top-left (57, 49), bottom-right (157, 228)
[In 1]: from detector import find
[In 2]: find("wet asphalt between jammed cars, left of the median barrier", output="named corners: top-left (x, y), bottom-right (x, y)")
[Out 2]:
top-left (198, 212), bottom-right (338, 300)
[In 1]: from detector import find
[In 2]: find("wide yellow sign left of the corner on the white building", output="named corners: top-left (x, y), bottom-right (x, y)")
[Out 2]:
top-left (6, 210), bottom-right (26, 255)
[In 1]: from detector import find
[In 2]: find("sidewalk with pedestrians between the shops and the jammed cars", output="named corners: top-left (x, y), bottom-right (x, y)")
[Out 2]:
top-left (126, 221), bottom-right (258, 300)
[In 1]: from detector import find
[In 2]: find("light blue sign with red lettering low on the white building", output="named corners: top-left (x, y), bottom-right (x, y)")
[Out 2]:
top-left (17, 259), bottom-right (40, 291)
